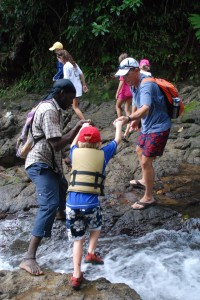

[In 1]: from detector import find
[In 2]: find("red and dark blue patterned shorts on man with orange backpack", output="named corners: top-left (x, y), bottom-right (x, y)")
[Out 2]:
top-left (137, 129), bottom-right (170, 157)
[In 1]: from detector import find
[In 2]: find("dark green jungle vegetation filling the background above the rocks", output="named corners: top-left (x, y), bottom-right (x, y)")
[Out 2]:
top-left (0, 0), bottom-right (200, 95)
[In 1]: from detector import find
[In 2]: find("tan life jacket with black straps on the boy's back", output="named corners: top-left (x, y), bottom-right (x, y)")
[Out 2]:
top-left (68, 148), bottom-right (105, 195)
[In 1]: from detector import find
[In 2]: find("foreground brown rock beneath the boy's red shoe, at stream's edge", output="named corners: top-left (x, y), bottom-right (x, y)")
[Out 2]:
top-left (0, 270), bottom-right (141, 300)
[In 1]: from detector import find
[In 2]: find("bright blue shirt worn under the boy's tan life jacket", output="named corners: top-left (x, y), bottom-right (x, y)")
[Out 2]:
top-left (66, 140), bottom-right (117, 209)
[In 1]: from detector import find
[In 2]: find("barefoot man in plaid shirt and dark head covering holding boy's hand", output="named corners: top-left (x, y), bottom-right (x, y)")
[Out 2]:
top-left (19, 79), bottom-right (88, 276)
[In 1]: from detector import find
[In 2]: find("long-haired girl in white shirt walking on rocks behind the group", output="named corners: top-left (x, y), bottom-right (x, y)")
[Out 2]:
top-left (57, 50), bottom-right (88, 120)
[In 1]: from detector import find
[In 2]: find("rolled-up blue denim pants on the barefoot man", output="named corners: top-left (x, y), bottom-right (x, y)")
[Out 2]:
top-left (26, 163), bottom-right (68, 237)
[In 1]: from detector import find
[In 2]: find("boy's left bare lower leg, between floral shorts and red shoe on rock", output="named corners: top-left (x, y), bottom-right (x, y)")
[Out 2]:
top-left (73, 238), bottom-right (85, 278)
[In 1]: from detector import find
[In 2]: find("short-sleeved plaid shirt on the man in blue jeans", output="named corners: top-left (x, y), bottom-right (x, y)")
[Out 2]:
top-left (25, 99), bottom-right (63, 173)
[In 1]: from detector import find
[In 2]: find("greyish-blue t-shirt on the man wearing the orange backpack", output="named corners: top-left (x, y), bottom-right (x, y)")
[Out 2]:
top-left (132, 75), bottom-right (171, 134)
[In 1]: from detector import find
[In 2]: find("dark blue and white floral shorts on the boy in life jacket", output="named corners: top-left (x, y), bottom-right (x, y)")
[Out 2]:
top-left (66, 206), bottom-right (102, 240)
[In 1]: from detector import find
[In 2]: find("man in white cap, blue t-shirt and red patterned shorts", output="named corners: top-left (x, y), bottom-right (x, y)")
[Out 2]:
top-left (115, 57), bottom-right (171, 210)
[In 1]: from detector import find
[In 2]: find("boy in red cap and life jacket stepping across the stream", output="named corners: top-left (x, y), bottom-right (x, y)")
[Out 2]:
top-left (66, 121), bottom-right (122, 289)
